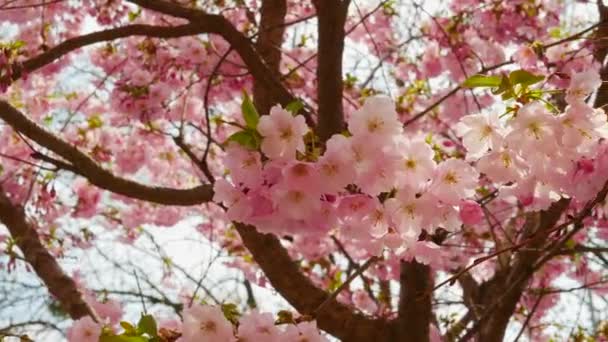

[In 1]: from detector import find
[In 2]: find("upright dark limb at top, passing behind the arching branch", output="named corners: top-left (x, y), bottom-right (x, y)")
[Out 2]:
top-left (253, 0), bottom-right (287, 114)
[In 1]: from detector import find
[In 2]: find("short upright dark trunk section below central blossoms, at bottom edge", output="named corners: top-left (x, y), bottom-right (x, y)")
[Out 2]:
top-left (393, 260), bottom-right (433, 342)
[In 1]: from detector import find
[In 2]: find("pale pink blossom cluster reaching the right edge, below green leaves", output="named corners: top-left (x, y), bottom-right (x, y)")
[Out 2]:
top-left (456, 70), bottom-right (608, 210)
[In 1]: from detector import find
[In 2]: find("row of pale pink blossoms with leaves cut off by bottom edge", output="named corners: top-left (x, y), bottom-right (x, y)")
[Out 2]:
top-left (68, 304), bottom-right (327, 342)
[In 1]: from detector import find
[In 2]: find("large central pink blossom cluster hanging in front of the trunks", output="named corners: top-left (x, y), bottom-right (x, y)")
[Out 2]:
top-left (214, 96), bottom-right (479, 255)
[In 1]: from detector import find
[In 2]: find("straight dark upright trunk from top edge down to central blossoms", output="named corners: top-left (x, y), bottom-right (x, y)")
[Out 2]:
top-left (314, 0), bottom-right (350, 141)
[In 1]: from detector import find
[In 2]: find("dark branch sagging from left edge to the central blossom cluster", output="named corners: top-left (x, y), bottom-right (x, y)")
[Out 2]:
top-left (0, 100), bottom-right (213, 206)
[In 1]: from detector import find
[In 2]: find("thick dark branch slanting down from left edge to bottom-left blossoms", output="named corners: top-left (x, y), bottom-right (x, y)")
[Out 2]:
top-left (0, 188), bottom-right (98, 320)
